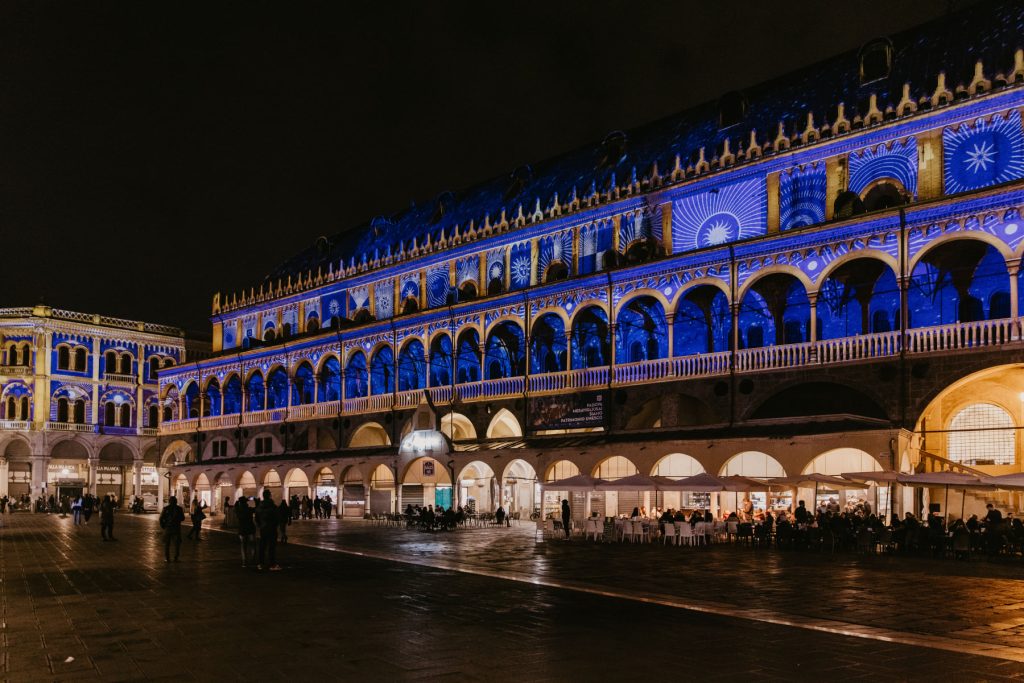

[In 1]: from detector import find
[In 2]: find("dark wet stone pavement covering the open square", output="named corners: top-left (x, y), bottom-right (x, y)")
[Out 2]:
top-left (0, 514), bottom-right (1024, 682)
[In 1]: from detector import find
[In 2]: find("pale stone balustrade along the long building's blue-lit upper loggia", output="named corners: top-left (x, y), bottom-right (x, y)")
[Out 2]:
top-left (157, 318), bottom-right (1024, 434)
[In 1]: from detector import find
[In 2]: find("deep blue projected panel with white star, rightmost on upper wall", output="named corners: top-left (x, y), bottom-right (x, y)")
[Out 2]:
top-left (942, 110), bottom-right (1024, 194)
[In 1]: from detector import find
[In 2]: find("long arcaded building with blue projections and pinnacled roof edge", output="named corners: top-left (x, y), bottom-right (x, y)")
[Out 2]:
top-left (160, 3), bottom-right (1024, 515)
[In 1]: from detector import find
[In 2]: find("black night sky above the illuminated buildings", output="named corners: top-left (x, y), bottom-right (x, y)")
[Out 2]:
top-left (0, 0), bottom-right (966, 334)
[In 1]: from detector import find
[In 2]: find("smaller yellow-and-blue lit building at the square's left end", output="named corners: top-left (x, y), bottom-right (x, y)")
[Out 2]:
top-left (0, 306), bottom-right (185, 500)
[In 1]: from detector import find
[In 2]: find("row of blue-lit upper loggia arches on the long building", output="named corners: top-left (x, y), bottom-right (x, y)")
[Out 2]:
top-left (164, 236), bottom-right (1021, 420)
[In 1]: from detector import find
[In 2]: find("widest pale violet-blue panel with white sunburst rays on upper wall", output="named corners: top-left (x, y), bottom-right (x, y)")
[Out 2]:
top-left (672, 180), bottom-right (767, 252)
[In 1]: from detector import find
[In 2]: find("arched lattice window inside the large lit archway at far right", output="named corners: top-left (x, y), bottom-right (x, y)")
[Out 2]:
top-left (946, 403), bottom-right (1015, 465)
